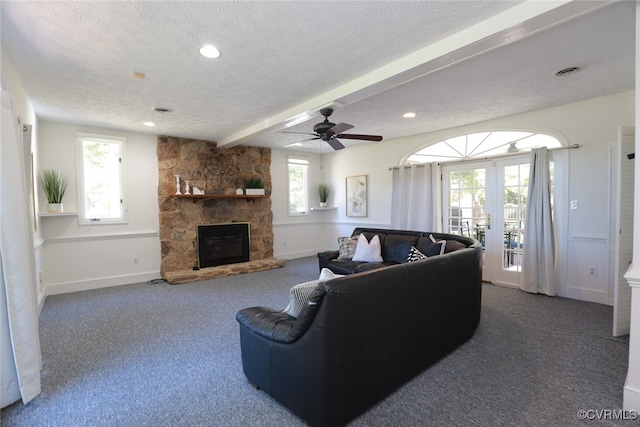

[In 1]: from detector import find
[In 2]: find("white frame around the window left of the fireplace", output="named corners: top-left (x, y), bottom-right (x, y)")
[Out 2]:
top-left (76, 133), bottom-right (128, 225)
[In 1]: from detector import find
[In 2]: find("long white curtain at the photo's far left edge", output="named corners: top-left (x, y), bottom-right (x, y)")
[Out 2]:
top-left (0, 92), bottom-right (41, 407)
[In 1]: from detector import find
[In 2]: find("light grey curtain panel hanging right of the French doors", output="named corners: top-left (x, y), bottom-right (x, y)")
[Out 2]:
top-left (520, 147), bottom-right (557, 296)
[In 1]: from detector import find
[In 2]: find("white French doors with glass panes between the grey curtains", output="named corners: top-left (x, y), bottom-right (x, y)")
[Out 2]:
top-left (442, 155), bottom-right (529, 286)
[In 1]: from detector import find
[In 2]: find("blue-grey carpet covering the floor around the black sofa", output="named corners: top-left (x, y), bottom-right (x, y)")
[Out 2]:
top-left (0, 257), bottom-right (634, 427)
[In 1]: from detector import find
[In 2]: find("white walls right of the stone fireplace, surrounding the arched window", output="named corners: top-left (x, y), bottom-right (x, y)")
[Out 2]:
top-left (272, 91), bottom-right (635, 304)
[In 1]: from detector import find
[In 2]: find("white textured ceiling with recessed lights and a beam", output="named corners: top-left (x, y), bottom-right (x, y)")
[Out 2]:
top-left (0, 0), bottom-right (635, 152)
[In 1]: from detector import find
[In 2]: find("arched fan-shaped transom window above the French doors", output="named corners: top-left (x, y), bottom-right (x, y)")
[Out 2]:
top-left (405, 131), bottom-right (562, 165)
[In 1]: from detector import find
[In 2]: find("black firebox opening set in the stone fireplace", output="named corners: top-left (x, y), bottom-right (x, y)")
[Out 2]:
top-left (198, 222), bottom-right (250, 268)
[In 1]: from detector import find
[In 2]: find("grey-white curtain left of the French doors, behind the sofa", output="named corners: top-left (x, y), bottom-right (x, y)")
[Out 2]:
top-left (391, 163), bottom-right (439, 231)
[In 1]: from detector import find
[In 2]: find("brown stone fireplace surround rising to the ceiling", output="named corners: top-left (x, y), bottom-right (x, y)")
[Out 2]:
top-left (157, 136), bottom-right (273, 275)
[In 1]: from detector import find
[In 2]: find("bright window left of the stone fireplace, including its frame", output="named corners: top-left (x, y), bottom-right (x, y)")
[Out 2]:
top-left (77, 134), bottom-right (126, 224)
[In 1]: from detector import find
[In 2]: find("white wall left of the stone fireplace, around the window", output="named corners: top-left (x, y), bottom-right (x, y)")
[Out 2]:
top-left (38, 121), bottom-right (160, 295)
